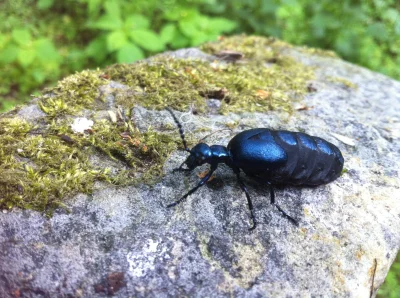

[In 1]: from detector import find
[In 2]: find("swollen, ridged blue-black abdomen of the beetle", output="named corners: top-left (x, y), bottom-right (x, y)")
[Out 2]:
top-left (228, 128), bottom-right (344, 185)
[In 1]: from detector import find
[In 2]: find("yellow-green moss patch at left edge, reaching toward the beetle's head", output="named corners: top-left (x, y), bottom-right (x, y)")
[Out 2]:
top-left (0, 118), bottom-right (179, 214)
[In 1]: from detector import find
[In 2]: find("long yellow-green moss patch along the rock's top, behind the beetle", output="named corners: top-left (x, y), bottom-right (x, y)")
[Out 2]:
top-left (105, 36), bottom-right (313, 113)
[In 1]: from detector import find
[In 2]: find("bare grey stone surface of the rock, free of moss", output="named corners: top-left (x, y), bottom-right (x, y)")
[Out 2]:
top-left (0, 43), bottom-right (400, 297)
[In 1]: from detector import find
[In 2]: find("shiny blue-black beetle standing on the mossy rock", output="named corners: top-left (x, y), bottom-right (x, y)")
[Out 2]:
top-left (167, 108), bottom-right (344, 230)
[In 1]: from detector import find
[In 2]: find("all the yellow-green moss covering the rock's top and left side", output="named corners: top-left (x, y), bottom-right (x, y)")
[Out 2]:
top-left (0, 36), bottom-right (313, 214)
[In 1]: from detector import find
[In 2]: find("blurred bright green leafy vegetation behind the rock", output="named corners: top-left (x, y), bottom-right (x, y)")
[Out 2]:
top-left (0, 0), bottom-right (400, 297)
